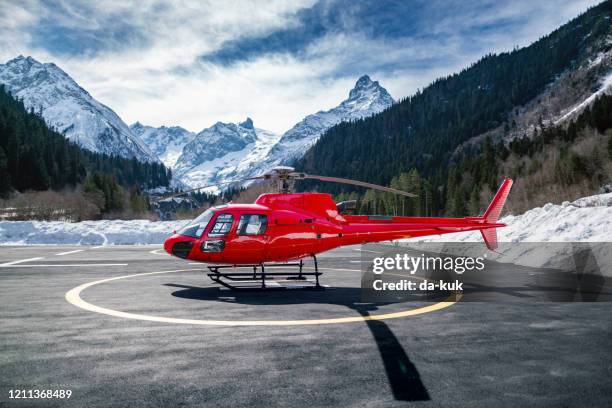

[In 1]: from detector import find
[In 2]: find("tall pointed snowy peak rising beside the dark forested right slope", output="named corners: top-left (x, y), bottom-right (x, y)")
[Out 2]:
top-left (250, 75), bottom-right (394, 175)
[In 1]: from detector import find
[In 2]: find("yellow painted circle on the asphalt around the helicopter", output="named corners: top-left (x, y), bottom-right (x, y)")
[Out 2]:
top-left (65, 268), bottom-right (461, 326)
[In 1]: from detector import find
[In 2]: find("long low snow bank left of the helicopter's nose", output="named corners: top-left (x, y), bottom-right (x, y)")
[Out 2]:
top-left (0, 220), bottom-right (187, 245)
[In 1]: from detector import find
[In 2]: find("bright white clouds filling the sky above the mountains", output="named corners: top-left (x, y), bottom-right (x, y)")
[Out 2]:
top-left (0, 0), bottom-right (594, 133)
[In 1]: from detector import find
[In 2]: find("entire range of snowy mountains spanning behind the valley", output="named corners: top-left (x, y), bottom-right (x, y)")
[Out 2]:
top-left (0, 55), bottom-right (395, 187)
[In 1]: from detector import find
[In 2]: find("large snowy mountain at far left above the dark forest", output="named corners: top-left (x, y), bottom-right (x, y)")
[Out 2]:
top-left (0, 55), bottom-right (158, 161)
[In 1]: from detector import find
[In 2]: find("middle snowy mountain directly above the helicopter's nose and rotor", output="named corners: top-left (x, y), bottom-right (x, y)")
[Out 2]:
top-left (173, 118), bottom-right (280, 187)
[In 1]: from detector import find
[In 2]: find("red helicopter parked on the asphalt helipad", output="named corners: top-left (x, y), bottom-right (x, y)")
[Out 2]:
top-left (164, 167), bottom-right (512, 289)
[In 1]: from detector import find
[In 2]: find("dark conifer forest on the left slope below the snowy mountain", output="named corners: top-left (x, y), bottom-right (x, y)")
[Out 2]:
top-left (0, 85), bottom-right (172, 196)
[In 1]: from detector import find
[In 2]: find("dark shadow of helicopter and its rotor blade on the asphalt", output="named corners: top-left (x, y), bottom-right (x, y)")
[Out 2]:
top-left (166, 283), bottom-right (431, 401)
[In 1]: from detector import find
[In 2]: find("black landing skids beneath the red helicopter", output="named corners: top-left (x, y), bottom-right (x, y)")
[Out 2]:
top-left (207, 255), bottom-right (325, 290)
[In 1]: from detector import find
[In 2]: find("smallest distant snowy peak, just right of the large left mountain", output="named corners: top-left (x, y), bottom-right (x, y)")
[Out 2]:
top-left (130, 122), bottom-right (195, 168)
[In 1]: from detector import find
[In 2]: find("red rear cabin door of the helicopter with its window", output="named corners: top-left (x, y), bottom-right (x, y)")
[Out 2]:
top-left (232, 214), bottom-right (268, 263)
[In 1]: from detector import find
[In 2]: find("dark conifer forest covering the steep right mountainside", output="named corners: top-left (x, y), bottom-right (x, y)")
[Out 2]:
top-left (296, 1), bottom-right (612, 215)
